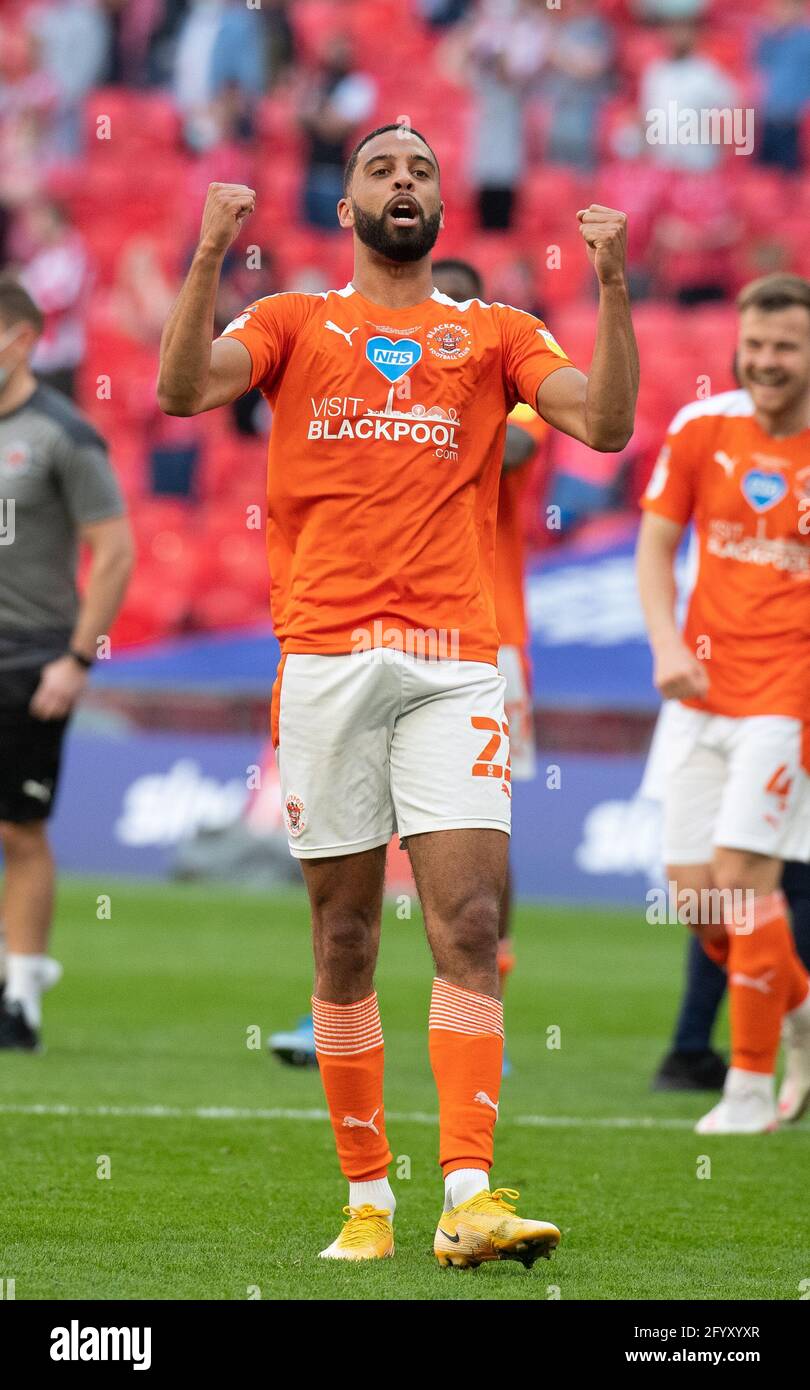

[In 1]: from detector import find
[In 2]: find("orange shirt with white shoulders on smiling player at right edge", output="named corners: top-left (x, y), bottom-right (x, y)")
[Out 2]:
top-left (642, 391), bottom-right (810, 721)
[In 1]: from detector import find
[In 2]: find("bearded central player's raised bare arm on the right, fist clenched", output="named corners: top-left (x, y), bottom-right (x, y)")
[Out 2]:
top-left (536, 203), bottom-right (639, 453)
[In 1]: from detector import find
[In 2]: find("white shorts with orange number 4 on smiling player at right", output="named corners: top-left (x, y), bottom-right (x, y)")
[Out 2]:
top-left (640, 701), bottom-right (810, 865)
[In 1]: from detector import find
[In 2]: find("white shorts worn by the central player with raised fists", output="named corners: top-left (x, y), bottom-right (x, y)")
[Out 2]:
top-left (274, 648), bottom-right (511, 859)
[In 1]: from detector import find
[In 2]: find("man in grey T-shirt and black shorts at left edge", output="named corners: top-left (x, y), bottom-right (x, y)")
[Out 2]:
top-left (0, 277), bottom-right (133, 1051)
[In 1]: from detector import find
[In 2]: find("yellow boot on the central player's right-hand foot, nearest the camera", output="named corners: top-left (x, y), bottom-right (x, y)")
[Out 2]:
top-left (433, 1187), bottom-right (560, 1269)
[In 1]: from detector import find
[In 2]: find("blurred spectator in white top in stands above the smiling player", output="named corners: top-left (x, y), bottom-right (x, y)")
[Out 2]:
top-left (640, 22), bottom-right (736, 172)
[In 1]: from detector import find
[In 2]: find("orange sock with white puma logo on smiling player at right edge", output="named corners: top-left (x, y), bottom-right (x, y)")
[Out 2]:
top-left (728, 891), bottom-right (807, 1076)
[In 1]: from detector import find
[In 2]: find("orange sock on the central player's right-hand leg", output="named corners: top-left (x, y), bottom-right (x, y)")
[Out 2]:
top-left (428, 980), bottom-right (503, 1177)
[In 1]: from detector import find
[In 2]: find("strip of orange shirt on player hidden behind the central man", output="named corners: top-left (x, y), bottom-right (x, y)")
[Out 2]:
top-left (495, 402), bottom-right (549, 646)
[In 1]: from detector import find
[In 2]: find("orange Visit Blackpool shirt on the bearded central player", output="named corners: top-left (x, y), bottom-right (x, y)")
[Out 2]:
top-left (215, 285), bottom-right (571, 664)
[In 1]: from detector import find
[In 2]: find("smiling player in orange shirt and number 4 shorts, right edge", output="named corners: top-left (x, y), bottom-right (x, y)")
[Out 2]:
top-left (638, 274), bottom-right (810, 1134)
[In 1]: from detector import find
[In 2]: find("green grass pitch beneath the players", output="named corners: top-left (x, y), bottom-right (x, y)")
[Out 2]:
top-left (0, 880), bottom-right (810, 1300)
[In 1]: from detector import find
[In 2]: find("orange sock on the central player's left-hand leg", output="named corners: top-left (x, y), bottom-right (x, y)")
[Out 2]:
top-left (313, 994), bottom-right (390, 1183)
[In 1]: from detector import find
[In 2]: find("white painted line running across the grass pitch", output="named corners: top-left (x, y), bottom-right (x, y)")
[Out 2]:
top-left (0, 1105), bottom-right (695, 1130)
